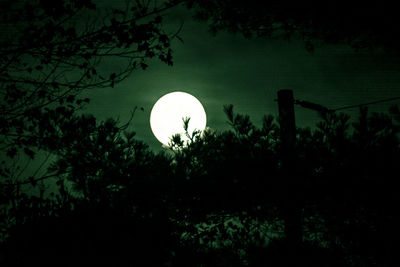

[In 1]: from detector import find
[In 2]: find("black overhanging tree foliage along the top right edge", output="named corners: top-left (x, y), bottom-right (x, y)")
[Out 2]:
top-left (186, 0), bottom-right (400, 53)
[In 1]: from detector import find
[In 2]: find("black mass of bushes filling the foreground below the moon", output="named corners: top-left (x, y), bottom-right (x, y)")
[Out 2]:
top-left (1, 106), bottom-right (400, 266)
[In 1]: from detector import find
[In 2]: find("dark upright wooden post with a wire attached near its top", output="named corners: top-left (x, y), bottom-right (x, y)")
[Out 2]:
top-left (278, 90), bottom-right (302, 262)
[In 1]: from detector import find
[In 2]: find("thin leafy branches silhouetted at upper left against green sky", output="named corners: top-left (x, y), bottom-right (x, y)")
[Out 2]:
top-left (0, 0), bottom-right (181, 194)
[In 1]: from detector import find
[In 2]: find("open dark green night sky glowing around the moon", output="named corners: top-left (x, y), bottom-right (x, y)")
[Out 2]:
top-left (80, 4), bottom-right (400, 151)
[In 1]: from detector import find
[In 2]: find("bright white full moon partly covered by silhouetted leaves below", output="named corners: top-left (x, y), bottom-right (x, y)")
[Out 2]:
top-left (150, 92), bottom-right (207, 146)
